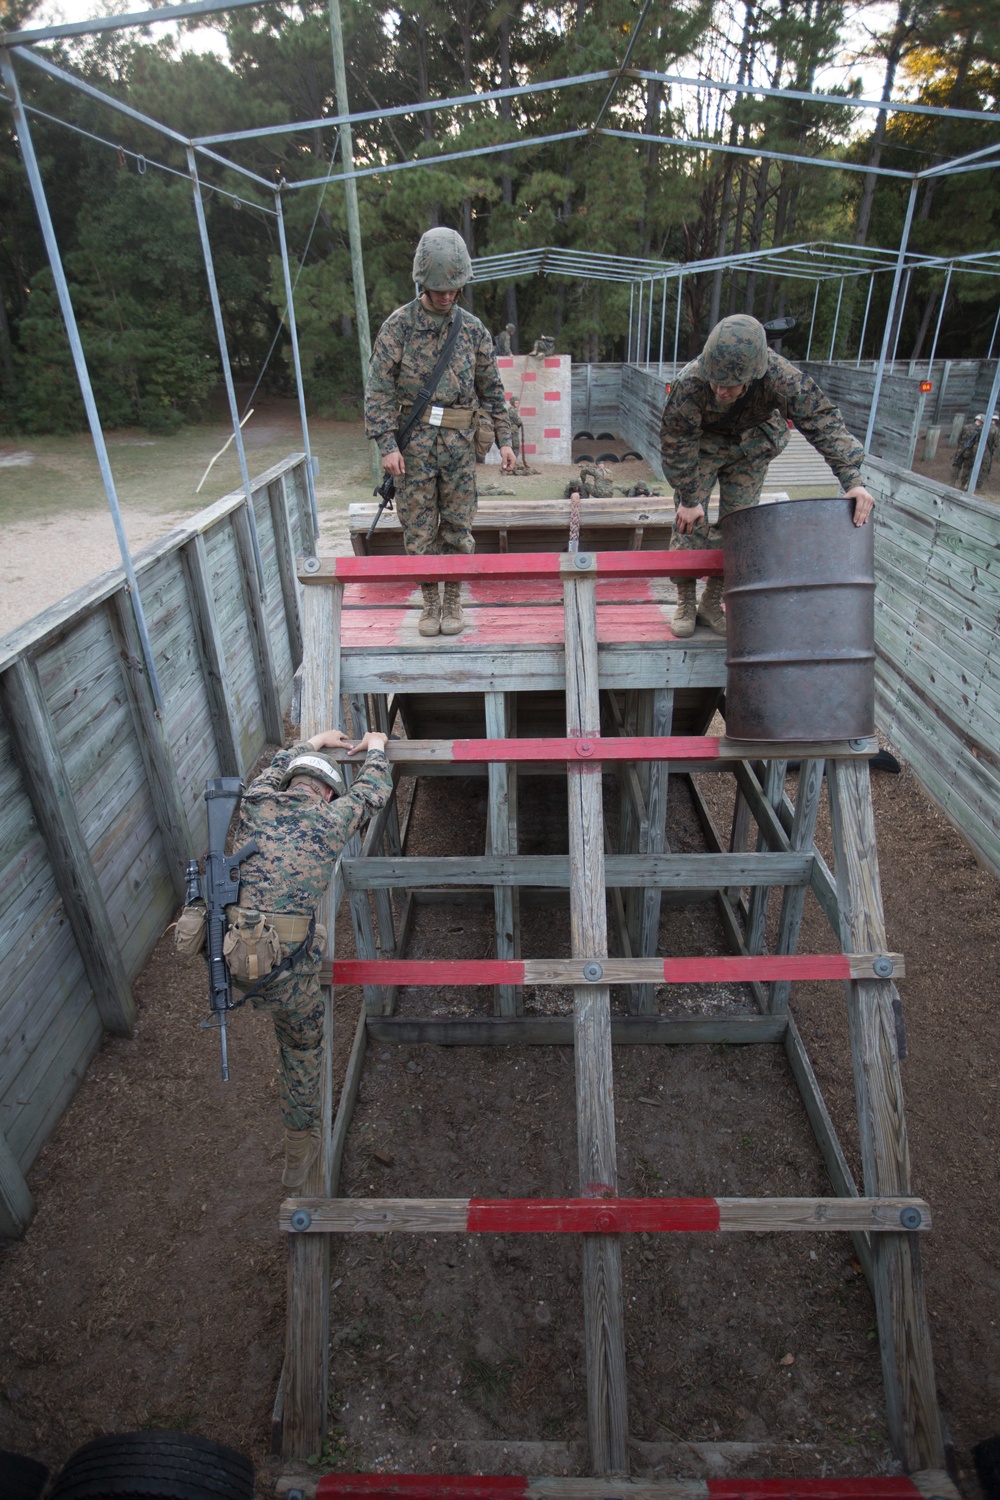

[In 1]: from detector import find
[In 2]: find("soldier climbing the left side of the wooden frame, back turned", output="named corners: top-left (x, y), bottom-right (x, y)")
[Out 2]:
top-left (235, 729), bottom-right (393, 1187)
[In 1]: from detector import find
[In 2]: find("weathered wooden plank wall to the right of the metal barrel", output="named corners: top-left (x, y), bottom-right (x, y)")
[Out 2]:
top-left (865, 459), bottom-right (1000, 878)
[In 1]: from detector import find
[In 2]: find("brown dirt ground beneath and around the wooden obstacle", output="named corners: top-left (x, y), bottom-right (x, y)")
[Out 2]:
top-left (0, 420), bottom-right (1000, 1500)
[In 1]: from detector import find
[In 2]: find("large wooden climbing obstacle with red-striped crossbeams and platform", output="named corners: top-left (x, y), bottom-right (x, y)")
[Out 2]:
top-left (279, 510), bottom-right (955, 1497)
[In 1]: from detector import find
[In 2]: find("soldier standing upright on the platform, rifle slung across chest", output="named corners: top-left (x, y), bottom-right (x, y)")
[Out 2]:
top-left (364, 230), bottom-right (516, 636)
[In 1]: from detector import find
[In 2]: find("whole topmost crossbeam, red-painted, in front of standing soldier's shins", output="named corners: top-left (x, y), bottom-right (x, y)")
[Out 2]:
top-left (298, 548), bottom-right (723, 584)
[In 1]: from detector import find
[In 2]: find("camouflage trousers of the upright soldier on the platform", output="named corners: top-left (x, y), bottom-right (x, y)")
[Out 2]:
top-left (396, 426), bottom-right (477, 557)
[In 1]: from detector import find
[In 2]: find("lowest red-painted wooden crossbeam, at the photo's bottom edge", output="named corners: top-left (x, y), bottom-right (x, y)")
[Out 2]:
top-left (314, 1475), bottom-right (929, 1500)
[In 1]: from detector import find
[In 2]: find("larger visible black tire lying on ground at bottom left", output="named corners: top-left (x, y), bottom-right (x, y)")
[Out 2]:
top-left (48, 1433), bottom-right (253, 1500)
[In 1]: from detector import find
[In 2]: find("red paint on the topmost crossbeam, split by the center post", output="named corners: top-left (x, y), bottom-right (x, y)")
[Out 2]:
top-left (330, 549), bottom-right (723, 584)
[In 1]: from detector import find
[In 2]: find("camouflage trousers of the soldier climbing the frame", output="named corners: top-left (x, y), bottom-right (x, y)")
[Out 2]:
top-left (250, 947), bottom-right (324, 1130)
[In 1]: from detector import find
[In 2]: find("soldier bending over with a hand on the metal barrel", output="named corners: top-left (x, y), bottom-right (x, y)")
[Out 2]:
top-left (660, 314), bottom-right (874, 636)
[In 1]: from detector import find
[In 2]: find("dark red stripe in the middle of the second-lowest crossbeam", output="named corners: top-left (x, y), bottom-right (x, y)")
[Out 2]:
top-left (466, 1199), bottom-right (718, 1235)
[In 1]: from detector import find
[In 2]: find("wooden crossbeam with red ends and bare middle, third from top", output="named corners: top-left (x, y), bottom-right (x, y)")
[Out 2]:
top-left (322, 953), bottom-right (906, 986)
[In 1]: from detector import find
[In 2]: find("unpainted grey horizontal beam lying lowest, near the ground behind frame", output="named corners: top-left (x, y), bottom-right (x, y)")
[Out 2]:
top-left (367, 1016), bottom-right (787, 1047)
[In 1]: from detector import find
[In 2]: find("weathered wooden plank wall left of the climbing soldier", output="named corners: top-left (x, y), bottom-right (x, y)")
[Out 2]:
top-left (0, 455), bottom-right (313, 1238)
